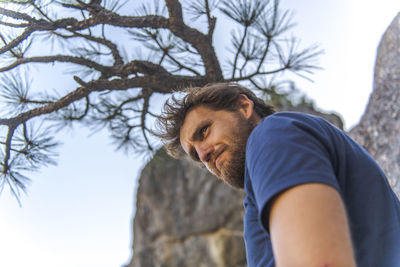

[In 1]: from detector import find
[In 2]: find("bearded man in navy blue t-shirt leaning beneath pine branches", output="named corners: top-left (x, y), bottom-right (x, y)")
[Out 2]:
top-left (158, 84), bottom-right (400, 267)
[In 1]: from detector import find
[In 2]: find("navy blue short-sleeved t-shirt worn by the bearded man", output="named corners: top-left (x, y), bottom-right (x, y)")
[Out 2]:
top-left (244, 112), bottom-right (400, 267)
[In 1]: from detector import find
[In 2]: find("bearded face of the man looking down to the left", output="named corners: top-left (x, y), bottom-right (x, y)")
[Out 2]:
top-left (180, 106), bottom-right (255, 188)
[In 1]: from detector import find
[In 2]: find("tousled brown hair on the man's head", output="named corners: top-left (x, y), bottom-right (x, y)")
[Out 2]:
top-left (154, 83), bottom-right (275, 158)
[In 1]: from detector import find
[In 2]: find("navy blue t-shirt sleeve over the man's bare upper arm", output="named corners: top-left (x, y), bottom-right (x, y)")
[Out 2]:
top-left (246, 115), bottom-right (340, 232)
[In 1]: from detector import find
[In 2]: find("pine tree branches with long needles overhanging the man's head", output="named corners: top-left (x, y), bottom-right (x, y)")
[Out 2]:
top-left (0, 0), bottom-right (320, 201)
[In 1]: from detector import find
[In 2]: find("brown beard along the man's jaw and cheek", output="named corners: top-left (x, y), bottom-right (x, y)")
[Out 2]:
top-left (218, 114), bottom-right (256, 189)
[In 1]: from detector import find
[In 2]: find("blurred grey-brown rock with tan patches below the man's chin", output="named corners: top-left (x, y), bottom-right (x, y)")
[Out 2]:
top-left (128, 149), bottom-right (246, 267)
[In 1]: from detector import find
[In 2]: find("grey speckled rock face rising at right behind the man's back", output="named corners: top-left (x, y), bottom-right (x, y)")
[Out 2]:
top-left (350, 13), bottom-right (400, 197)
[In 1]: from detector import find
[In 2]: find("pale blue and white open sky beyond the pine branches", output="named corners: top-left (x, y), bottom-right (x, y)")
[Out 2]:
top-left (0, 0), bottom-right (400, 267)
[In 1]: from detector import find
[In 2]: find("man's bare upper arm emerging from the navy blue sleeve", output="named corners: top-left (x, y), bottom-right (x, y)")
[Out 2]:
top-left (269, 183), bottom-right (356, 267)
